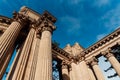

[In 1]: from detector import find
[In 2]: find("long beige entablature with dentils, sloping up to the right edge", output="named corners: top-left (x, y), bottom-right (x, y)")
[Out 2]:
top-left (83, 28), bottom-right (120, 60)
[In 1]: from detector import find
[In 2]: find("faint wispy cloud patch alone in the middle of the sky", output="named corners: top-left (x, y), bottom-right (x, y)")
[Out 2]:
top-left (60, 16), bottom-right (81, 35)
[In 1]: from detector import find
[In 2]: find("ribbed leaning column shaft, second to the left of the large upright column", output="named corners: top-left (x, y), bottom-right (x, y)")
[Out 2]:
top-left (8, 28), bottom-right (35, 80)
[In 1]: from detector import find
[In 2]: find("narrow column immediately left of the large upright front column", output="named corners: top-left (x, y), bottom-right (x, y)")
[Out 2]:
top-left (24, 32), bottom-right (40, 80)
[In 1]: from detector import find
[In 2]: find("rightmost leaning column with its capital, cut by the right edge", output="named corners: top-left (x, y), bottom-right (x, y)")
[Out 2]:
top-left (102, 50), bottom-right (120, 76)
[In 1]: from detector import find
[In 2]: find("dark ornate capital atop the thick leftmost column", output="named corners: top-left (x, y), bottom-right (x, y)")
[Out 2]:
top-left (13, 11), bottom-right (29, 25)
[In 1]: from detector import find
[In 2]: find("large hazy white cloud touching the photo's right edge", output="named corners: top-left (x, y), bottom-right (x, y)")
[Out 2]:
top-left (101, 5), bottom-right (120, 29)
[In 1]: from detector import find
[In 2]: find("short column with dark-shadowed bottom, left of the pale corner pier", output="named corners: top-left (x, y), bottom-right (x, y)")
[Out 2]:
top-left (62, 61), bottom-right (70, 80)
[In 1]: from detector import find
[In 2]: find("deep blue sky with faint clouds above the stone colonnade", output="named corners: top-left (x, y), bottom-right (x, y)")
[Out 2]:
top-left (0, 0), bottom-right (120, 79)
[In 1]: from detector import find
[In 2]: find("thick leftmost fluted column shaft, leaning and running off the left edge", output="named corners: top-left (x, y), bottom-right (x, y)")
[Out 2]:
top-left (0, 21), bottom-right (23, 61)
